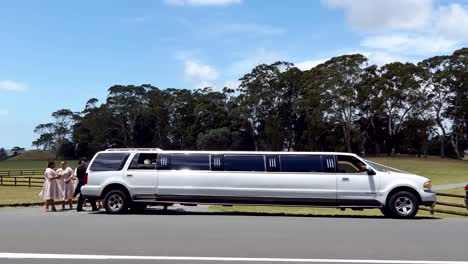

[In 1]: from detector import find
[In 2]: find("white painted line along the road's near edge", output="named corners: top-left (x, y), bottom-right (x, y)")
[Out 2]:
top-left (0, 253), bottom-right (468, 264)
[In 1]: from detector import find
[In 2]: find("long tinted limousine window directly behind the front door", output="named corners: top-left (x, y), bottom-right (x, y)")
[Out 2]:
top-left (280, 155), bottom-right (322, 172)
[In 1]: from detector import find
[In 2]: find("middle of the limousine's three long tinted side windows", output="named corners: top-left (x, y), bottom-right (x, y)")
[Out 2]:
top-left (224, 155), bottom-right (265, 171)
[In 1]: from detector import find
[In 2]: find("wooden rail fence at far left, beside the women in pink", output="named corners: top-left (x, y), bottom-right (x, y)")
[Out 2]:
top-left (0, 170), bottom-right (44, 187)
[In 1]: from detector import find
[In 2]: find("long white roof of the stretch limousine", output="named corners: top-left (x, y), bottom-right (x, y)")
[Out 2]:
top-left (105, 148), bottom-right (357, 156)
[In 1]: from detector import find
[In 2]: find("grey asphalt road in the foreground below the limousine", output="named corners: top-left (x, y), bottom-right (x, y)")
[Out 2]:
top-left (0, 208), bottom-right (468, 264)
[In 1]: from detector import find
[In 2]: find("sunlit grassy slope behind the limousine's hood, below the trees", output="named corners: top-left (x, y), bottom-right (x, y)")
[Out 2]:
top-left (369, 157), bottom-right (468, 184)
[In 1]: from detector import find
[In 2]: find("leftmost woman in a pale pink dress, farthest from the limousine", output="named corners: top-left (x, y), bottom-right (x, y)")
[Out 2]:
top-left (39, 161), bottom-right (63, 211)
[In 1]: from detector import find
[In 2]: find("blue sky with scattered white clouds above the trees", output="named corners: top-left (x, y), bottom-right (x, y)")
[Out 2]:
top-left (0, 0), bottom-right (468, 148)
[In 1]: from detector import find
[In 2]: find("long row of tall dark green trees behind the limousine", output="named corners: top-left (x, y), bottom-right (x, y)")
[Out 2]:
top-left (33, 48), bottom-right (468, 159)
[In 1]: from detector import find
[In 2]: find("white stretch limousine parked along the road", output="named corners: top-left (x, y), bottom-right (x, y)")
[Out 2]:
top-left (81, 149), bottom-right (436, 218)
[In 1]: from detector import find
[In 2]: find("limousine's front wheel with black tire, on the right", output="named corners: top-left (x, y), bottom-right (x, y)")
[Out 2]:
top-left (387, 191), bottom-right (419, 219)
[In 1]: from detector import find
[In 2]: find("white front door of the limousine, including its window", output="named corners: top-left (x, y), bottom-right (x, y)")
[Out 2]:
top-left (337, 155), bottom-right (379, 206)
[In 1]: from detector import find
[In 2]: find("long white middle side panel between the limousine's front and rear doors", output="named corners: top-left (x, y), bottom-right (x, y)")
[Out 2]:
top-left (157, 170), bottom-right (336, 200)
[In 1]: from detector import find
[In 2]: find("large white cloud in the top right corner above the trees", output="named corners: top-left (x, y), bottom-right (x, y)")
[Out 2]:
top-left (322, 0), bottom-right (468, 57)
